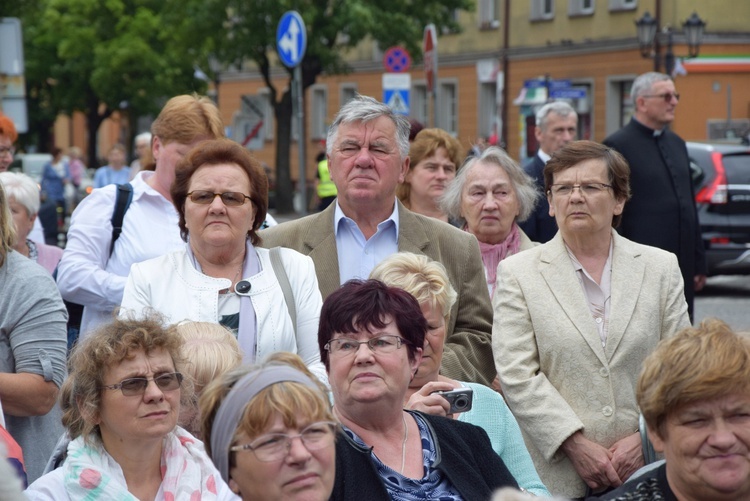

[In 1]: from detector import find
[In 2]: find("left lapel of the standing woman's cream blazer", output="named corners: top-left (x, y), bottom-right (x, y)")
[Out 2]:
top-left (539, 232), bottom-right (606, 365)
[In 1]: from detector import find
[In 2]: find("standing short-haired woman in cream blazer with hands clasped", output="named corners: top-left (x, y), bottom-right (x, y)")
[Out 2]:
top-left (493, 141), bottom-right (690, 498)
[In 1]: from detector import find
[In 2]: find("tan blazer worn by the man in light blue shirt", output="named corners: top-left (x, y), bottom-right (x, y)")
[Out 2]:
top-left (260, 201), bottom-right (495, 385)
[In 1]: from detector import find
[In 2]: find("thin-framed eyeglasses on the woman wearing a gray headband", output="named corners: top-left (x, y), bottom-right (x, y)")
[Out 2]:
top-left (229, 421), bottom-right (338, 462)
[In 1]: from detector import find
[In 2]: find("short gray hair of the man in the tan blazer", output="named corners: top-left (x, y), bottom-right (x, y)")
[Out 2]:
top-left (326, 94), bottom-right (411, 159)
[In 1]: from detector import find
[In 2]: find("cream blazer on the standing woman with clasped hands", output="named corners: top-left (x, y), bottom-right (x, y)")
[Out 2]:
top-left (493, 230), bottom-right (690, 497)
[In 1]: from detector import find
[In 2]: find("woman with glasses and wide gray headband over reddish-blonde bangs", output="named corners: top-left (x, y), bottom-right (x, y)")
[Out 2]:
top-left (200, 353), bottom-right (338, 501)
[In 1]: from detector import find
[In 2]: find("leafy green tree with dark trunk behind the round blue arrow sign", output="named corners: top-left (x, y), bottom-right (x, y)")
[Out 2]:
top-left (206, 0), bottom-right (474, 212)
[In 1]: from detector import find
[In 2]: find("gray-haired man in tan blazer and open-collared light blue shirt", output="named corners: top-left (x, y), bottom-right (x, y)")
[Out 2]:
top-left (260, 96), bottom-right (496, 385)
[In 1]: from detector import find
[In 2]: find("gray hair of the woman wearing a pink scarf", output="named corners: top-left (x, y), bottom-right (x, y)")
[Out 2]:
top-left (440, 146), bottom-right (541, 225)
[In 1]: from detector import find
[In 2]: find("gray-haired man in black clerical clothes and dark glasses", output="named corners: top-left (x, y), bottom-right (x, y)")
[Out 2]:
top-left (604, 72), bottom-right (706, 320)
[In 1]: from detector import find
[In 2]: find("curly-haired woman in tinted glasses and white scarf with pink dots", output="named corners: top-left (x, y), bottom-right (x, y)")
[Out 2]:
top-left (26, 319), bottom-right (235, 500)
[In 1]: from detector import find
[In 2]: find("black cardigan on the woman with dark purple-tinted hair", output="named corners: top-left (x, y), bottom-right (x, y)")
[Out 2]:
top-left (330, 412), bottom-right (518, 501)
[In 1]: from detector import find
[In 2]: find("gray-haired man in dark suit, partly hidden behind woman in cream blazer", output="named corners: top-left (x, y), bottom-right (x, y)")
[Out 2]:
top-left (519, 101), bottom-right (578, 243)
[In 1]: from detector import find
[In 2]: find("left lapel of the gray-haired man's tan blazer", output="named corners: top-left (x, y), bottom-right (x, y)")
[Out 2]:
top-left (304, 203), bottom-right (341, 299)
